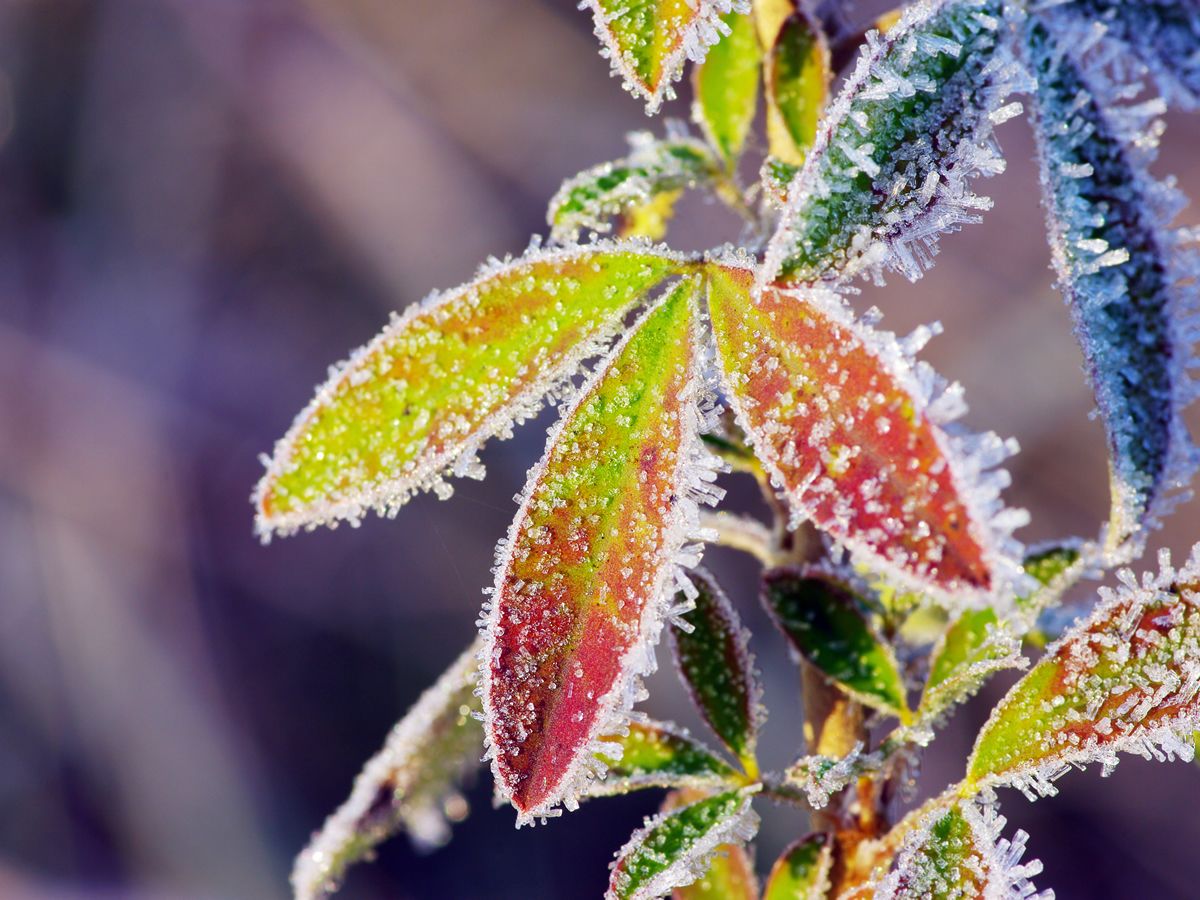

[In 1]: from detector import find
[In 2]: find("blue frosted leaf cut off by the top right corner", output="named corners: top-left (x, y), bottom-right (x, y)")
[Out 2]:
top-left (1062, 0), bottom-right (1200, 110)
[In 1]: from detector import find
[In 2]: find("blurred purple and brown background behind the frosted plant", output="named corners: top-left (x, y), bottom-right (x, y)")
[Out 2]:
top-left (0, 0), bottom-right (1200, 900)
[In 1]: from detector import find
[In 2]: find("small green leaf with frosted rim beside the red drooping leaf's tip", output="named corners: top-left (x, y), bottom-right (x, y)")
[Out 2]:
top-left (587, 721), bottom-right (737, 797)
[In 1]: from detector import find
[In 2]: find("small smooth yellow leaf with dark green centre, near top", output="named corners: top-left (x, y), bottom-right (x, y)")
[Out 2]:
top-left (766, 5), bottom-right (833, 166)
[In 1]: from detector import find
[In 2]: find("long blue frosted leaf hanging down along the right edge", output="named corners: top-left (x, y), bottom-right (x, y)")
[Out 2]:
top-left (1026, 11), bottom-right (1200, 562)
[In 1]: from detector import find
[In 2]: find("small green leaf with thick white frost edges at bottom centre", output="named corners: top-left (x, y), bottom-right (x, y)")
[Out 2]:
top-left (605, 788), bottom-right (758, 900)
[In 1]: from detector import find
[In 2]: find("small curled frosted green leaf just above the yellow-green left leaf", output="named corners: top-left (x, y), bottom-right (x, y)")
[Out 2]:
top-left (546, 131), bottom-right (719, 242)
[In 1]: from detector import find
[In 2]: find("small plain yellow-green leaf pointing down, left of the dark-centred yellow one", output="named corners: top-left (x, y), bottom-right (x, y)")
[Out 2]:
top-left (691, 12), bottom-right (762, 172)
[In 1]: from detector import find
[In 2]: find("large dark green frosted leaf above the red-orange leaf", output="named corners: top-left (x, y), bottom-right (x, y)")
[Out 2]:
top-left (760, 0), bottom-right (1027, 284)
